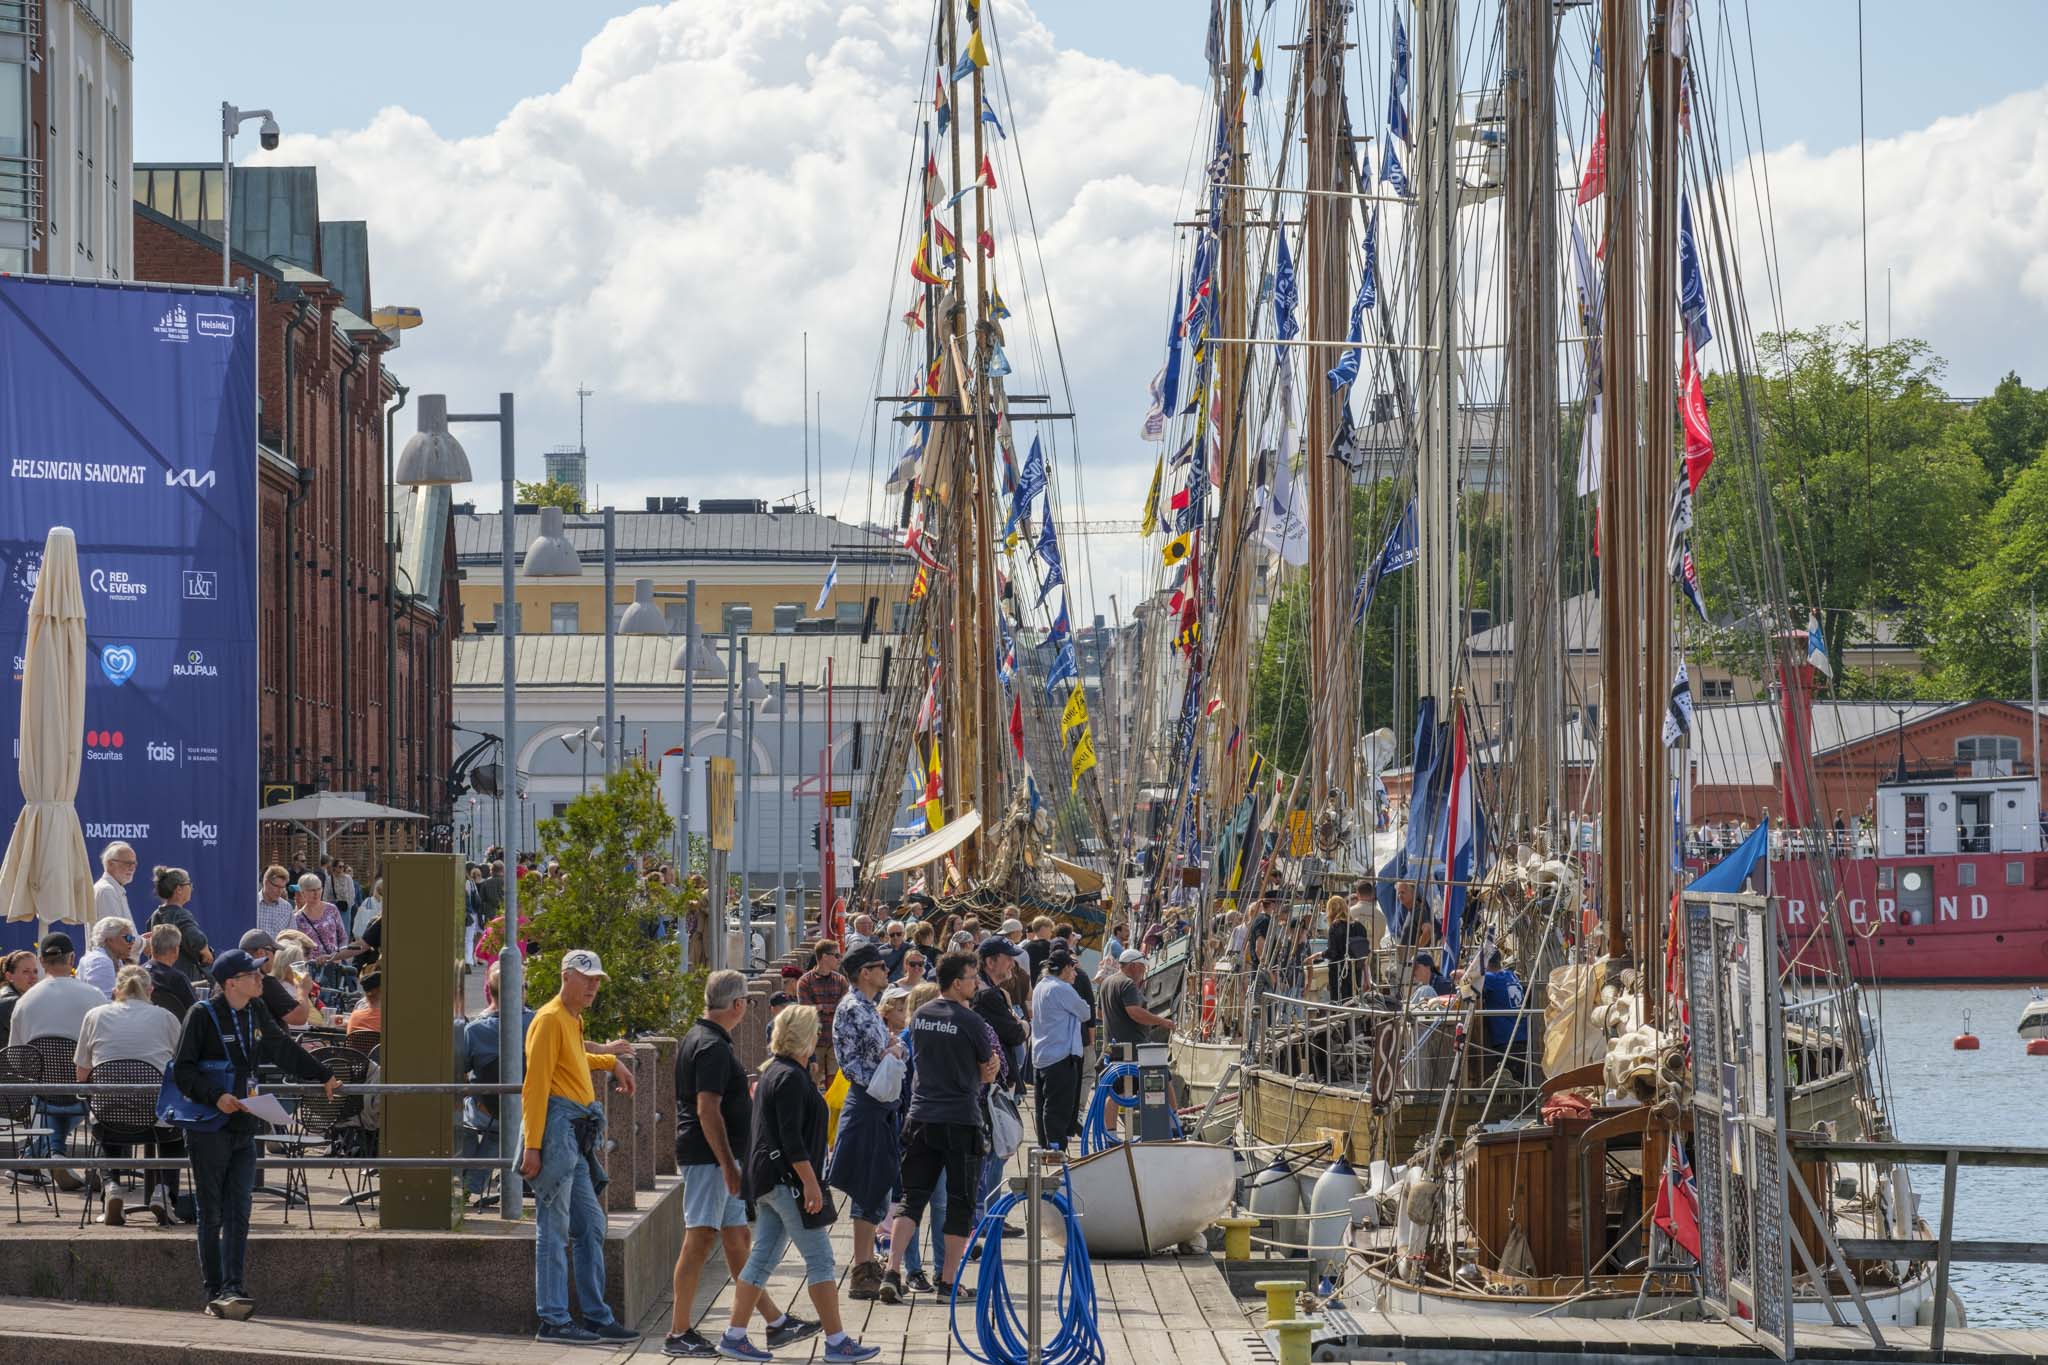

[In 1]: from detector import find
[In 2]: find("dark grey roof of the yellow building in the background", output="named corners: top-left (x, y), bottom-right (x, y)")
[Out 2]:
top-left (455, 508), bottom-right (903, 565)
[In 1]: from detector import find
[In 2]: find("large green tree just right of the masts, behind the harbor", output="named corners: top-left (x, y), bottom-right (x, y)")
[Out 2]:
top-left (1694, 325), bottom-right (1991, 675)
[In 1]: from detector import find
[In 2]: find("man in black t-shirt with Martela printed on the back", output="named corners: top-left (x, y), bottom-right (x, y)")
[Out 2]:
top-left (881, 954), bottom-right (1001, 1304)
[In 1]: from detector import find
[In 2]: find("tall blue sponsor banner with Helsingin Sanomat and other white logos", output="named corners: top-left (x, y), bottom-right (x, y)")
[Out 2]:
top-left (0, 276), bottom-right (260, 954)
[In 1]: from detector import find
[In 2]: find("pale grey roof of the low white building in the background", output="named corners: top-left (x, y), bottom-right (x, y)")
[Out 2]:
top-left (455, 634), bottom-right (903, 696)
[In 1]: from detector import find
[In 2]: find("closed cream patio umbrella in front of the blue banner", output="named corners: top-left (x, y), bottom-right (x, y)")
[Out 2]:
top-left (0, 526), bottom-right (92, 925)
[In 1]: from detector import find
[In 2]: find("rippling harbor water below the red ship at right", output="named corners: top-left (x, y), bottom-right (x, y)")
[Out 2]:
top-left (1872, 986), bottom-right (2048, 1328)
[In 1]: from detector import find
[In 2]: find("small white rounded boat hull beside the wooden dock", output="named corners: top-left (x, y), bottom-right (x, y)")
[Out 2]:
top-left (1067, 1142), bottom-right (1237, 1257)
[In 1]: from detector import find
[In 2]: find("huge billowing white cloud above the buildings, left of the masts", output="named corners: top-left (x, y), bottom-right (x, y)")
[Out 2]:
top-left (264, 0), bottom-right (1200, 609)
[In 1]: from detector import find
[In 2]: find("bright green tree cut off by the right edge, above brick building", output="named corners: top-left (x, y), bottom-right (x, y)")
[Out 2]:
top-left (1929, 450), bottom-right (2048, 698)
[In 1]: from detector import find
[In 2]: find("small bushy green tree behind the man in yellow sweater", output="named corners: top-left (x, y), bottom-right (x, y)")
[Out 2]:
top-left (520, 759), bottom-right (702, 1038)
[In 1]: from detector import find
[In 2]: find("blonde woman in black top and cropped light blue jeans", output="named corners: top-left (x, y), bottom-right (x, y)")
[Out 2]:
top-left (719, 1005), bottom-right (881, 1363)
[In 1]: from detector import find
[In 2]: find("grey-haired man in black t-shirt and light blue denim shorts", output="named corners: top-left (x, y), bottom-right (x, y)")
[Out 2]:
top-left (664, 972), bottom-right (798, 1359)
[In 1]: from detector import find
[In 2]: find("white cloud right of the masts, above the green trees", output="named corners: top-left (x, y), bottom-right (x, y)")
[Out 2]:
top-left (1731, 90), bottom-right (2048, 395)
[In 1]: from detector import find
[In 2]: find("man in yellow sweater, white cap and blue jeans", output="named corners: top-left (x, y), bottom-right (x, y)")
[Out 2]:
top-left (518, 948), bottom-right (639, 1345)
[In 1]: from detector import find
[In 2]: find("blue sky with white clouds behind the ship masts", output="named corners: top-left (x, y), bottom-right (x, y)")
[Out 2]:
top-left (123, 0), bottom-right (2048, 614)
